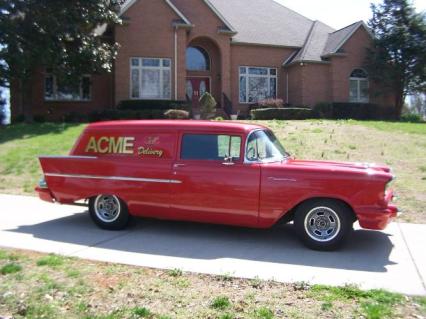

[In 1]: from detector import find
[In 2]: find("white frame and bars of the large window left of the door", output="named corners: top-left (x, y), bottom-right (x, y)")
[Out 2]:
top-left (129, 56), bottom-right (173, 101)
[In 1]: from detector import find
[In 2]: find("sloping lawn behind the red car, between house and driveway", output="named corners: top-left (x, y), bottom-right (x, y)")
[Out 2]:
top-left (0, 120), bottom-right (426, 223)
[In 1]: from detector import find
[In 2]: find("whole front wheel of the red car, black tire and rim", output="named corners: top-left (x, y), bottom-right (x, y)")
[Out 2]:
top-left (294, 199), bottom-right (354, 251)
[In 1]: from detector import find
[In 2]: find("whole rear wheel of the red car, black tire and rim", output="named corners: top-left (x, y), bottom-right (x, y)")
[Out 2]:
top-left (89, 194), bottom-right (130, 230)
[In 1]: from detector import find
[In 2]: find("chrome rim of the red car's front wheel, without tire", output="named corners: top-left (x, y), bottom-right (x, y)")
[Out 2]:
top-left (304, 207), bottom-right (341, 242)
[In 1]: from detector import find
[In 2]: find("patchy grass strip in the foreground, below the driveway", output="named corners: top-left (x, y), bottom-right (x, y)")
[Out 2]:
top-left (0, 249), bottom-right (426, 319)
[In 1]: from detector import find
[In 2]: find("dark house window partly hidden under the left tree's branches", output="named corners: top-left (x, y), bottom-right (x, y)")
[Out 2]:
top-left (44, 74), bottom-right (91, 101)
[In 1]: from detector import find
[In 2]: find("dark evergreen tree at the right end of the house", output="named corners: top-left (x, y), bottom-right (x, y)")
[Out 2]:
top-left (367, 0), bottom-right (426, 118)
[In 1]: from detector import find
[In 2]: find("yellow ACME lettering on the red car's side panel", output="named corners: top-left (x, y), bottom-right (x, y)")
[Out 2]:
top-left (85, 136), bottom-right (135, 155)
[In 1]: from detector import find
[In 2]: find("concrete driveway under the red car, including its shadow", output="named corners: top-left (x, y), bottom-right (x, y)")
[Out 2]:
top-left (0, 195), bottom-right (426, 295)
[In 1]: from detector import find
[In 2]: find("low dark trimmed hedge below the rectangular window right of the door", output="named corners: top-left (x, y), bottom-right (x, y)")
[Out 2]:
top-left (250, 107), bottom-right (314, 120)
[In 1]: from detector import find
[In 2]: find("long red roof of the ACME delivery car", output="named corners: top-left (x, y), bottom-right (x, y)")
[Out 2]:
top-left (88, 120), bottom-right (266, 132)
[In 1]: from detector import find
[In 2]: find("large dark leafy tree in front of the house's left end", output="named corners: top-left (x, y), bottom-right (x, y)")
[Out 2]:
top-left (0, 0), bottom-right (120, 121)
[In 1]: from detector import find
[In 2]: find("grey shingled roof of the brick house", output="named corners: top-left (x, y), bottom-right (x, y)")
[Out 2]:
top-left (120, 0), bottom-right (373, 65)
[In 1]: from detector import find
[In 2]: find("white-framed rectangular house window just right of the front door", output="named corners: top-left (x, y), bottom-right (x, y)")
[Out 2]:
top-left (240, 66), bottom-right (277, 103)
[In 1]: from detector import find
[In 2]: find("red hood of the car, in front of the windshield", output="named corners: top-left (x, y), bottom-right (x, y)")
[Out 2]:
top-left (287, 159), bottom-right (391, 173)
